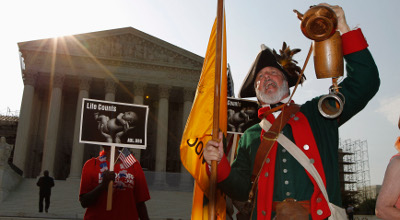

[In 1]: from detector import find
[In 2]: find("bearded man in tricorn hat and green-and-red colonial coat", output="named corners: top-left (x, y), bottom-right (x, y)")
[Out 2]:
top-left (204, 4), bottom-right (380, 220)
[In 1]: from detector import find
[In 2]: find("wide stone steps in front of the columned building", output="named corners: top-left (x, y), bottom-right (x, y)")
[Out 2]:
top-left (0, 172), bottom-right (193, 220)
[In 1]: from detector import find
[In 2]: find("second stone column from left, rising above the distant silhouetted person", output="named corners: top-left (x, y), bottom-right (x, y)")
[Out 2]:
top-left (40, 75), bottom-right (65, 176)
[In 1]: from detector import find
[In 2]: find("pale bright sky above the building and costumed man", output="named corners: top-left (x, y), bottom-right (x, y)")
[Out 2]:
top-left (0, 0), bottom-right (400, 185)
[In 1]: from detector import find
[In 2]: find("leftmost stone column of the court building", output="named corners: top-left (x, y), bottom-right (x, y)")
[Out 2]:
top-left (13, 71), bottom-right (38, 175)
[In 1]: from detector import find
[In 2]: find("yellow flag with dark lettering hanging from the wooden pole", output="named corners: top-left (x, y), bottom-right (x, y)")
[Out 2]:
top-left (180, 9), bottom-right (227, 220)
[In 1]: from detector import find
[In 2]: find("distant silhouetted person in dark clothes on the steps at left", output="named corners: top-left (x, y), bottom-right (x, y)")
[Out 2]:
top-left (36, 170), bottom-right (54, 212)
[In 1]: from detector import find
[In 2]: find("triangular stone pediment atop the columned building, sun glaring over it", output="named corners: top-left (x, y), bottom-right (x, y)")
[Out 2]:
top-left (18, 27), bottom-right (203, 70)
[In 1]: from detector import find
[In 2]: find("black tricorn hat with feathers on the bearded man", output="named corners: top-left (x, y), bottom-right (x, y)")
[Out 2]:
top-left (239, 42), bottom-right (305, 98)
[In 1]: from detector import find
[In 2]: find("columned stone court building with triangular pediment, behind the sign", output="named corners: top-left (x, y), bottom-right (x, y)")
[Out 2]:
top-left (13, 27), bottom-right (204, 179)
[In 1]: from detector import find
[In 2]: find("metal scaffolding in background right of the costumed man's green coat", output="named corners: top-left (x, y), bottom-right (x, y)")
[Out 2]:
top-left (339, 139), bottom-right (374, 201)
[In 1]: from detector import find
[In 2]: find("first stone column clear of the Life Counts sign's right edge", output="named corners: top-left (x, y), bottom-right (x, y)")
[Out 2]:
top-left (156, 86), bottom-right (170, 172)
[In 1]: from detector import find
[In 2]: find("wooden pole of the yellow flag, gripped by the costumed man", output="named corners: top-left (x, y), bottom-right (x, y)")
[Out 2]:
top-left (209, 0), bottom-right (224, 220)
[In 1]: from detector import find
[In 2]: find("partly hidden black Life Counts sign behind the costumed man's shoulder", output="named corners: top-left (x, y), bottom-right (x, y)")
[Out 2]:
top-left (227, 98), bottom-right (260, 134)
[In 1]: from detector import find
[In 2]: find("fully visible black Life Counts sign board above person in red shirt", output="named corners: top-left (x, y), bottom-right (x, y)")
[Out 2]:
top-left (79, 99), bottom-right (148, 149)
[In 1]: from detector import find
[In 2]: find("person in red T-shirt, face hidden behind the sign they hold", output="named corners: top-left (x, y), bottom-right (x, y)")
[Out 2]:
top-left (79, 146), bottom-right (150, 220)
